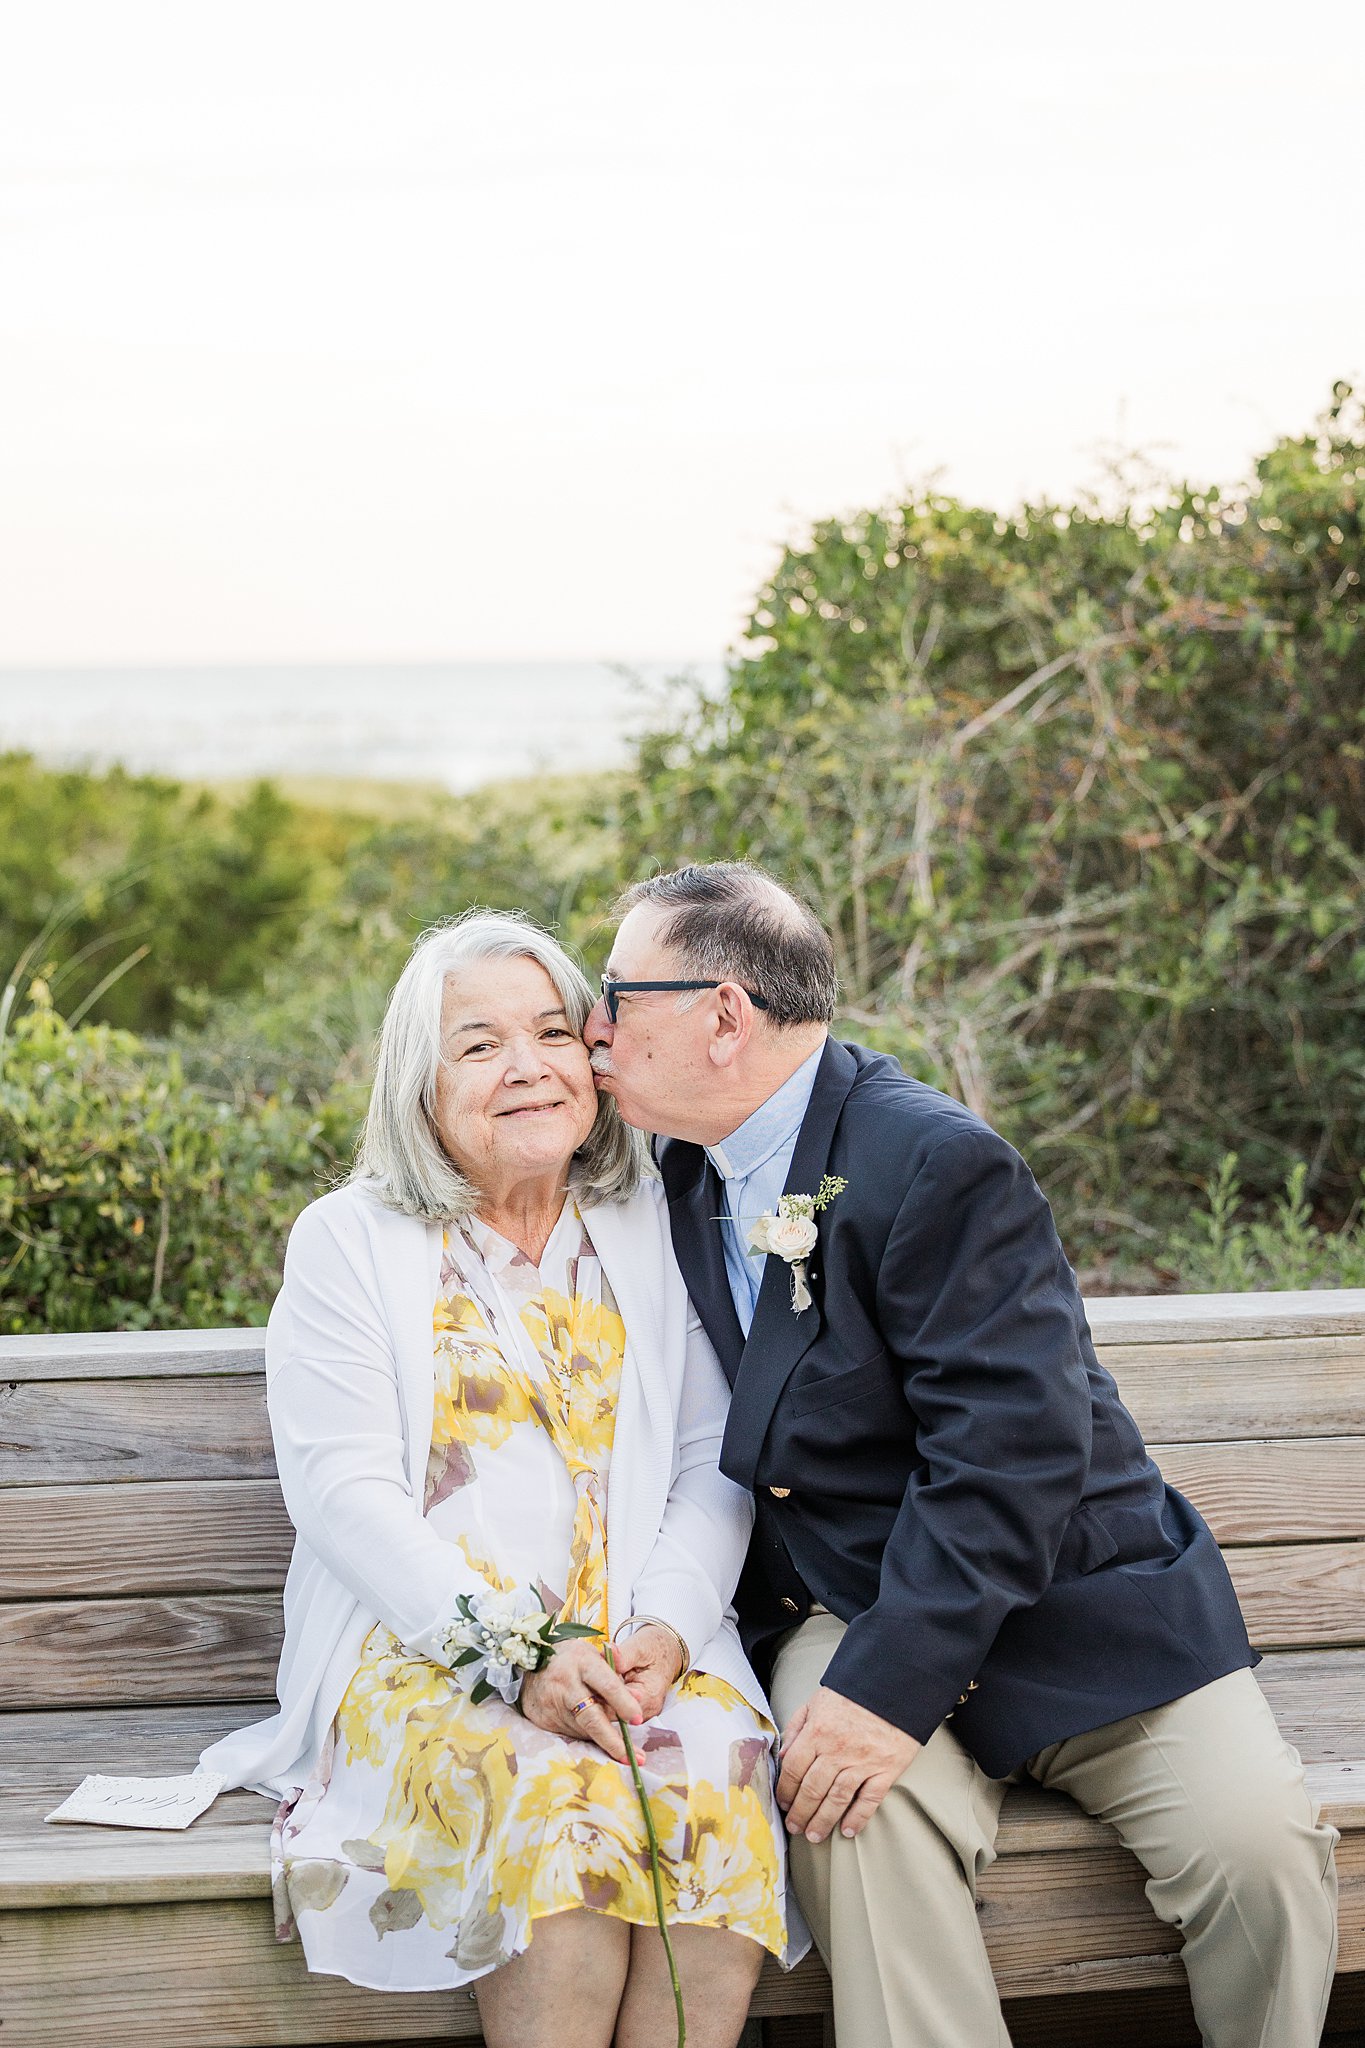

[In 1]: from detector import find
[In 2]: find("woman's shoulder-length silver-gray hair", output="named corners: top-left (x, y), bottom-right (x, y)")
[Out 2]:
top-left (348, 909), bottom-right (649, 1223)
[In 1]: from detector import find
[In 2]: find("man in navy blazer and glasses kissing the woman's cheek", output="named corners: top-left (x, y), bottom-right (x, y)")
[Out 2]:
top-left (585, 862), bottom-right (1336, 2048)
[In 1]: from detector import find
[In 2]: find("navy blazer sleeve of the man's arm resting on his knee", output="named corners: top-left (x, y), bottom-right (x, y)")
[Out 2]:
top-left (825, 1128), bottom-right (1091, 1743)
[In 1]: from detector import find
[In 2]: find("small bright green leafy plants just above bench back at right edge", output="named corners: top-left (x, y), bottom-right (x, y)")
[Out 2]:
top-left (1171, 1153), bottom-right (1365, 1294)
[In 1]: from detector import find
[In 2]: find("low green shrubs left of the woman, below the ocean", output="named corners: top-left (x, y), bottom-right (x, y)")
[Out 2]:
top-left (0, 758), bottom-right (614, 1331)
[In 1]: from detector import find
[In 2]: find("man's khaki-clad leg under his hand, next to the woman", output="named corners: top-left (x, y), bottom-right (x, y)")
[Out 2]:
top-left (772, 1610), bottom-right (1009, 2048)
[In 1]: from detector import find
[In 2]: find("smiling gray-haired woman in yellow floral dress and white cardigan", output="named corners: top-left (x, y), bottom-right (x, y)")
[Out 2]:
top-left (203, 911), bottom-right (802, 2048)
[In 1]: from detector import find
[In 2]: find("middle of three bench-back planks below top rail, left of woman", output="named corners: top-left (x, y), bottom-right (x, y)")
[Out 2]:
top-left (0, 1479), bottom-right (295, 1599)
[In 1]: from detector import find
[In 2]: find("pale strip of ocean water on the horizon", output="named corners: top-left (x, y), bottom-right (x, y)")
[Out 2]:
top-left (0, 662), bottom-right (722, 791)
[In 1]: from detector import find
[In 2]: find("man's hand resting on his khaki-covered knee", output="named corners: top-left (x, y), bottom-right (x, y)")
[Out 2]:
top-left (778, 1686), bottom-right (921, 1841)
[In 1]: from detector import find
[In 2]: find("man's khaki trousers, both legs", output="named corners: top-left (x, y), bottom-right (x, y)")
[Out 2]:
top-left (772, 1610), bottom-right (1336, 2048)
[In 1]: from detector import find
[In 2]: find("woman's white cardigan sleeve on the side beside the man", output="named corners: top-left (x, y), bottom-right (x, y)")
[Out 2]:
top-left (630, 1303), bottom-right (753, 1657)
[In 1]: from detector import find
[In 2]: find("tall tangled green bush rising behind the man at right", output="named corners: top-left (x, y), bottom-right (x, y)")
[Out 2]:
top-left (622, 385), bottom-right (1365, 1264)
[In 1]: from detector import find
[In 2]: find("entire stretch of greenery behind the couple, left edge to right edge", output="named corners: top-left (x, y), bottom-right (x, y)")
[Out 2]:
top-left (0, 385), bottom-right (1365, 1329)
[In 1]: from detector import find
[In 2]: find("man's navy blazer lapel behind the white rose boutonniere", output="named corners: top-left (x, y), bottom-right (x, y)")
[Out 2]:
top-left (720, 1038), bottom-right (857, 1487)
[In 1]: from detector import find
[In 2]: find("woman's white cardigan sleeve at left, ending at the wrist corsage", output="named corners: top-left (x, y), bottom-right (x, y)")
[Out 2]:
top-left (266, 1204), bottom-right (479, 1663)
